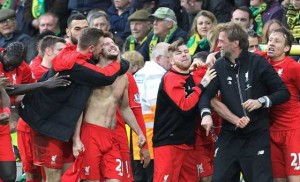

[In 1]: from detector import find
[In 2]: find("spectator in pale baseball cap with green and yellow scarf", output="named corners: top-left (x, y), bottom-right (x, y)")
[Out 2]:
top-left (139, 7), bottom-right (187, 61)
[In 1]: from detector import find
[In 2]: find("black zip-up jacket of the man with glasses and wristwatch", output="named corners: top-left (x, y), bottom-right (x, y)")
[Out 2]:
top-left (199, 51), bottom-right (290, 135)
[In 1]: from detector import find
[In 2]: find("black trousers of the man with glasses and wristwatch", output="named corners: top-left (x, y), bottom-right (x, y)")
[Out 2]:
top-left (213, 129), bottom-right (273, 182)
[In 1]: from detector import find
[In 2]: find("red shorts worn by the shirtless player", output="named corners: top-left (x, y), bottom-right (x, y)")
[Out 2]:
top-left (80, 123), bottom-right (123, 181)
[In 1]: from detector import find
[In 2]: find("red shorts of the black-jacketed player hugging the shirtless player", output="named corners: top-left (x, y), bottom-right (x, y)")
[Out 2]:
top-left (31, 130), bottom-right (74, 169)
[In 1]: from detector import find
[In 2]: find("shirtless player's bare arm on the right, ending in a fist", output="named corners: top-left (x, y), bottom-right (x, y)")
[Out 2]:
top-left (119, 78), bottom-right (146, 148)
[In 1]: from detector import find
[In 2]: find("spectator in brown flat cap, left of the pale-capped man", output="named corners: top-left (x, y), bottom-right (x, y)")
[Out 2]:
top-left (123, 9), bottom-right (151, 52)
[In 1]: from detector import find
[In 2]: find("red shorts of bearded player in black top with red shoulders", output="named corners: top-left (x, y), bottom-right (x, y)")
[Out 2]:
top-left (153, 145), bottom-right (198, 182)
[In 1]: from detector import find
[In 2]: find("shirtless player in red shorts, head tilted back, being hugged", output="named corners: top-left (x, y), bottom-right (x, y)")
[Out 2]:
top-left (73, 34), bottom-right (146, 182)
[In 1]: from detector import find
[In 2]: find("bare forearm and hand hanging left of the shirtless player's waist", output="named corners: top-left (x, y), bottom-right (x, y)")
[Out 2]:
top-left (73, 113), bottom-right (85, 157)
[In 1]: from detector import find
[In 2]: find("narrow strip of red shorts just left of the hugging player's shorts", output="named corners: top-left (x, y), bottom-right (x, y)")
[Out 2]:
top-left (17, 130), bottom-right (40, 173)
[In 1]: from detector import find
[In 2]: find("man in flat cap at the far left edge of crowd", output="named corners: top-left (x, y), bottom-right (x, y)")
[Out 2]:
top-left (0, 9), bottom-right (30, 48)
